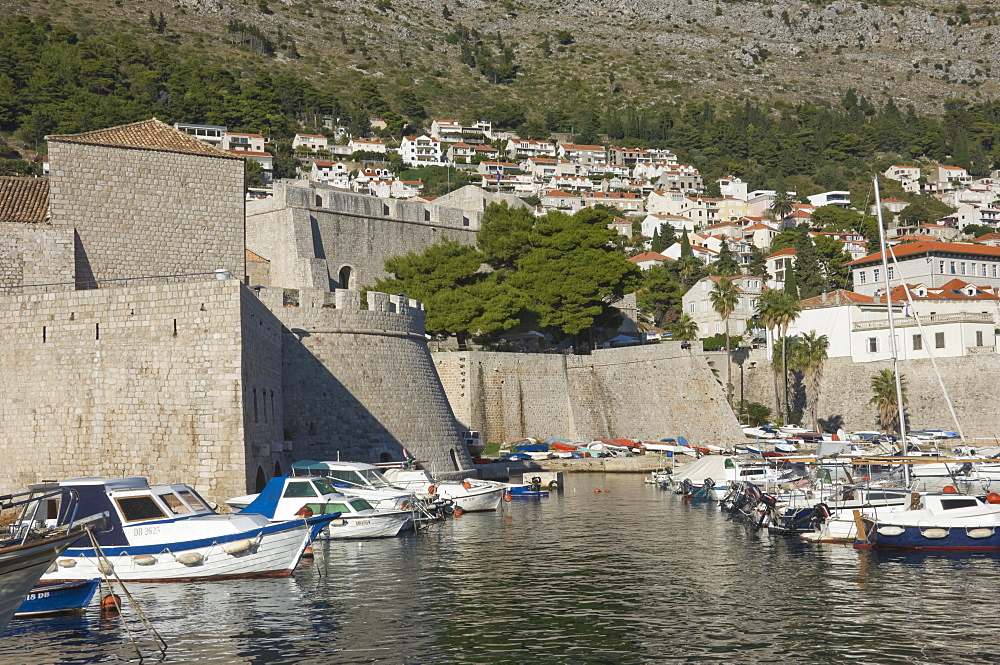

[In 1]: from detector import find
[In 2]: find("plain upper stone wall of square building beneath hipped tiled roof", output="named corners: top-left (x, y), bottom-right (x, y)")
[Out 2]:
top-left (49, 141), bottom-right (244, 281)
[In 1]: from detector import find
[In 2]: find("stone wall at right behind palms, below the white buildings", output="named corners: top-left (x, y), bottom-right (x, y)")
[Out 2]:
top-left (734, 350), bottom-right (1000, 442)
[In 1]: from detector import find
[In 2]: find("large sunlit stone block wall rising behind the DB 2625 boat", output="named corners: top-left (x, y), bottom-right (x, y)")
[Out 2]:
top-left (0, 279), bottom-right (252, 500)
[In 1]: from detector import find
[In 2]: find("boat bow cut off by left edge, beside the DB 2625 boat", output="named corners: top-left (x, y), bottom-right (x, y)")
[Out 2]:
top-left (0, 490), bottom-right (97, 632)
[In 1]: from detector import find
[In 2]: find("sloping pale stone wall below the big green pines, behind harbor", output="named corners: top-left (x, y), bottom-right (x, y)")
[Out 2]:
top-left (433, 343), bottom-right (742, 445)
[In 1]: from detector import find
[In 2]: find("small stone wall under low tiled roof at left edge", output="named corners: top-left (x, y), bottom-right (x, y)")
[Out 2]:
top-left (0, 222), bottom-right (74, 286)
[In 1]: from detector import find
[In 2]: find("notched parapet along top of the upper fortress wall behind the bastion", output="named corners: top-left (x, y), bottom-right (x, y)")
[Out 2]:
top-left (266, 182), bottom-right (483, 231)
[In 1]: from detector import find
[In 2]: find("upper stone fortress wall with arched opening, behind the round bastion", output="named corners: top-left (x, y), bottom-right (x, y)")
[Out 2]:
top-left (247, 182), bottom-right (482, 290)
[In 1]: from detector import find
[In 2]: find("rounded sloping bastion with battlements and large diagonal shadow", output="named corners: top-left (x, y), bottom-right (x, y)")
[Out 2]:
top-left (260, 289), bottom-right (472, 473)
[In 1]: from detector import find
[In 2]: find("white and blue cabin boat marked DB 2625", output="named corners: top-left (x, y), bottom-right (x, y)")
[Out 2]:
top-left (42, 478), bottom-right (336, 582)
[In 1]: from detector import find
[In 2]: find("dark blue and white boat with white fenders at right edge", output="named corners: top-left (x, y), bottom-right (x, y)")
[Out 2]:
top-left (854, 493), bottom-right (1000, 552)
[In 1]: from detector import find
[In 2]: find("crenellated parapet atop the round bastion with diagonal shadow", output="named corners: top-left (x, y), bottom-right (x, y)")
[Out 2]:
top-left (254, 287), bottom-right (425, 340)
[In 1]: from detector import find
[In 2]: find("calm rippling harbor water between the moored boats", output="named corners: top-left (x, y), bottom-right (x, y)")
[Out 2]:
top-left (0, 474), bottom-right (1000, 665)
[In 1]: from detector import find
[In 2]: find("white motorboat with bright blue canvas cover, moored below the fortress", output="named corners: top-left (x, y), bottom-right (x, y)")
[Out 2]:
top-left (226, 476), bottom-right (414, 539)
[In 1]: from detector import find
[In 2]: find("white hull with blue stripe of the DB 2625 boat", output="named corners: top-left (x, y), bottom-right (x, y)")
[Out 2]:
top-left (42, 517), bottom-right (333, 582)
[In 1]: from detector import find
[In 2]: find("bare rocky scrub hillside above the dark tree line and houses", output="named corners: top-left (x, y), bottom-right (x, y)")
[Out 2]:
top-left (0, 0), bottom-right (1000, 115)
